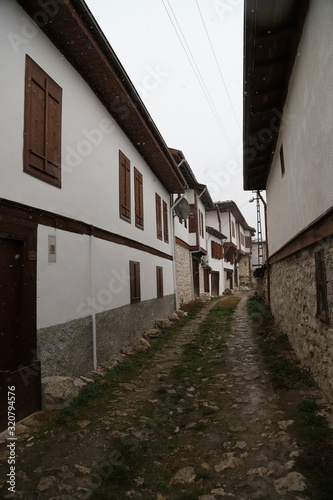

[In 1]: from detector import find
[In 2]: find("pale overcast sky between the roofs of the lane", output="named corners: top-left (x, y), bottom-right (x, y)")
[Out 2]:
top-left (86, 0), bottom-right (256, 227)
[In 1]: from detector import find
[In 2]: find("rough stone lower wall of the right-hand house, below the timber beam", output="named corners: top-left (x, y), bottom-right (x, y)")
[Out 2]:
top-left (271, 236), bottom-right (333, 398)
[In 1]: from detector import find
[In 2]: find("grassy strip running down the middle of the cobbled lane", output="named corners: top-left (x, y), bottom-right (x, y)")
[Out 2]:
top-left (91, 297), bottom-right (240, 500)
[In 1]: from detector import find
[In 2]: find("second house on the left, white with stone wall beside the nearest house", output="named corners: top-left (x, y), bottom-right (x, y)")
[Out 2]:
top-left (170, 148), bottom-right (217, 304)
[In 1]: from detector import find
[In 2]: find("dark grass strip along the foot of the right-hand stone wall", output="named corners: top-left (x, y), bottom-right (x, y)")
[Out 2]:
top-left (247, 294), bottom-right (333, 500)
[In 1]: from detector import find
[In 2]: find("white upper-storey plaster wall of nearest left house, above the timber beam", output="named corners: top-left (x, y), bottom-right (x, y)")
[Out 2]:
top-left (0, 0), bottom-right (172, 254)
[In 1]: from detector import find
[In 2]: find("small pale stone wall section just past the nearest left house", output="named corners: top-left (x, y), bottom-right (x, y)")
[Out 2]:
top-left (176, 245), bottom-right (194, 305)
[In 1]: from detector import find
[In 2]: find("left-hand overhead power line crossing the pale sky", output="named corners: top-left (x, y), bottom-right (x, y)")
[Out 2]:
top-left (162, 0), bottom-right (239, 163)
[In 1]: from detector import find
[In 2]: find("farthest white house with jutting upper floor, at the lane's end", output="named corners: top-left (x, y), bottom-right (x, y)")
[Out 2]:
top-left (216, 200), bottom-right (255, 290)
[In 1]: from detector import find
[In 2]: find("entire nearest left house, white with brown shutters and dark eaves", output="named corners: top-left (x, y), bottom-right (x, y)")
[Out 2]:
top-left (0, 0), bottom-right (184, 427)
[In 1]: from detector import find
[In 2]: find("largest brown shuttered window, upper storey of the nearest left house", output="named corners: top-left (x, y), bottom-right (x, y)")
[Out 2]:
top-left (23, 55), bottom-right (62, 188)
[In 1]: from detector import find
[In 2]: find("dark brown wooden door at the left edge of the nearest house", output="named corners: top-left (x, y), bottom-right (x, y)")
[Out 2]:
top-left (0, 221), bottom-right (41, 431)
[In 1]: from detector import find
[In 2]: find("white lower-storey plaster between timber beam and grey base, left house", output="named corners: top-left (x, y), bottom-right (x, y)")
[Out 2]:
top-left (37, 225), bottom-right (174, 328)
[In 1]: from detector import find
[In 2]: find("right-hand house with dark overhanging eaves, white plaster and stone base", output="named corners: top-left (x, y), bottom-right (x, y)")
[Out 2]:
top-left (244, 0), bottom-right (333, 397)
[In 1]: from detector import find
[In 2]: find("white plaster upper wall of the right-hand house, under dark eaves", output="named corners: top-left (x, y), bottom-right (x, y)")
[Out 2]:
top-left (266, 0), bottom-right (333, 255)
